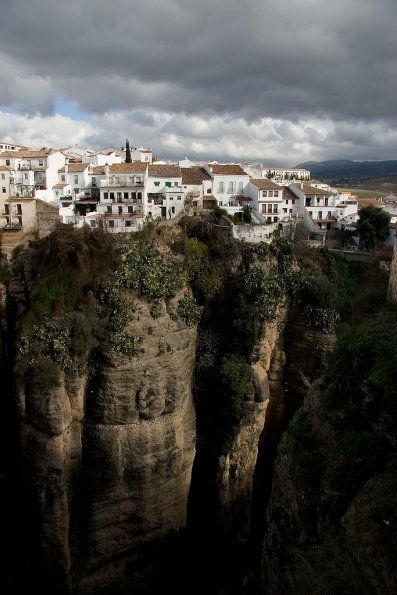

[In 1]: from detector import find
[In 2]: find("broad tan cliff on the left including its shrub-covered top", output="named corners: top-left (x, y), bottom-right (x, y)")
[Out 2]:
top-left (2, 229), bottom-right (196, 593)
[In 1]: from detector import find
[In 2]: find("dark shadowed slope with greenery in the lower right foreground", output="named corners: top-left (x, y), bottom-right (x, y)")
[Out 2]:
top-left (263, 280), bottom-right (397, 594)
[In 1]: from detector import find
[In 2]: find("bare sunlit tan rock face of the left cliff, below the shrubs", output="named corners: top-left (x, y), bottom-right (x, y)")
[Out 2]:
top-left (19, 301), bottom-right (196, 592)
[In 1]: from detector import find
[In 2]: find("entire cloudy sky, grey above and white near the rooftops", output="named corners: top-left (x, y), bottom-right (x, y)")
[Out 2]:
top-left (0, 0), bottom-right (397, 165)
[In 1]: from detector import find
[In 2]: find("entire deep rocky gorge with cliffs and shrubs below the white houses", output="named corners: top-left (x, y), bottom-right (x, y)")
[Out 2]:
top-left (0, 218), bottom-right (397, 595)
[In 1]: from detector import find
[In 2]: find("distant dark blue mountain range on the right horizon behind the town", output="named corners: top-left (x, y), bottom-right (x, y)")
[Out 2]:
top-left (295, 159), bottom-right (397, 186)
